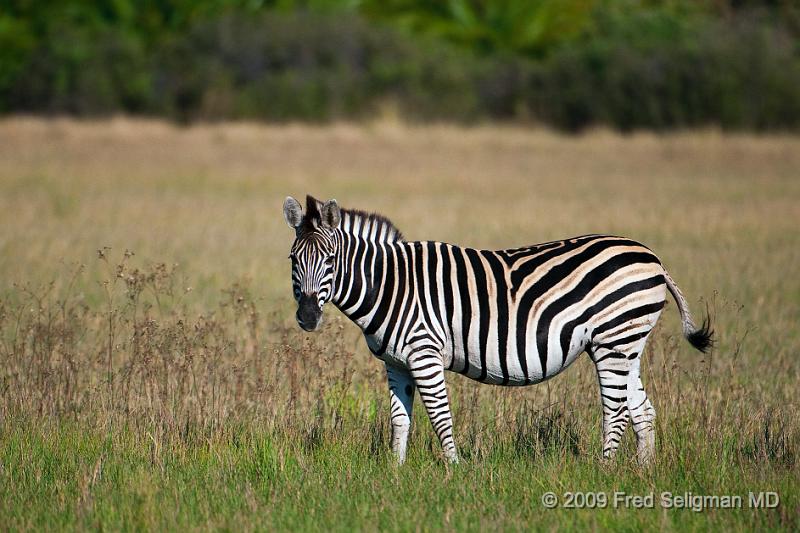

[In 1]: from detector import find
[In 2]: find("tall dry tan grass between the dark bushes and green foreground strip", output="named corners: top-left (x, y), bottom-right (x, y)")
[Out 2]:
top-left (0, 119), bottom-right (800, 526)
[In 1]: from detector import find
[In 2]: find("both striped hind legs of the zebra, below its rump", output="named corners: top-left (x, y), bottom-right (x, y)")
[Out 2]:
top-left (591, 331), bottom-right (656, 465)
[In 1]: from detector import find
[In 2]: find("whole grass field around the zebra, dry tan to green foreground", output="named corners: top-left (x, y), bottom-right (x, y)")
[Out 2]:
top-left (0, 118), bottom-right (800, 531)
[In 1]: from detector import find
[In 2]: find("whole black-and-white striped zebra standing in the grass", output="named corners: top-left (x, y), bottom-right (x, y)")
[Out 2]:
top-left (283, 195), bottom-right (713, 464)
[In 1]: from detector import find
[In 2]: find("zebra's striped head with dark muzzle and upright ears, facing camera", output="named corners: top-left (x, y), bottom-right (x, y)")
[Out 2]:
top-left (283, 196), bottom-right (342, 331)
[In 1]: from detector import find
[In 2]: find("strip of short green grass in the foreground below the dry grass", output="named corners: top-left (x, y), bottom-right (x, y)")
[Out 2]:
top-left (0, 423), bottom-right (798, 531)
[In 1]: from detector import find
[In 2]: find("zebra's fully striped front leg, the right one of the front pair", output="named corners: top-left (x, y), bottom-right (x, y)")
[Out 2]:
top-left (408, 350), bottom-right (458, 463)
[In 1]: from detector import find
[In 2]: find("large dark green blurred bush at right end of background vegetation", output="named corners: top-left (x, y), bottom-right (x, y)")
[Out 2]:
top-left (529, 8), bottom-right (800, 130)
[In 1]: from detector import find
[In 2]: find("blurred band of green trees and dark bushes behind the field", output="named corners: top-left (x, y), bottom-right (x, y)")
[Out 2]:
top-left (0, 0), bottom-right (800, 131)
